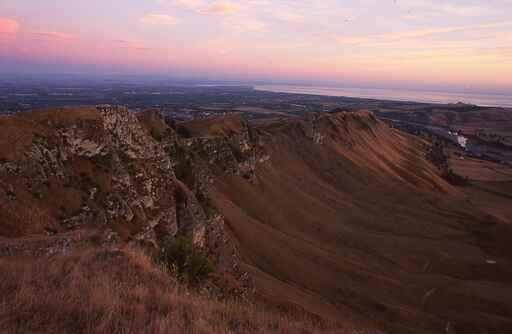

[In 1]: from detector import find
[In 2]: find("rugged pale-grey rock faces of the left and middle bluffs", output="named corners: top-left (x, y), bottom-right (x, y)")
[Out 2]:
top-left (0, 105), bottom-right (255, 298)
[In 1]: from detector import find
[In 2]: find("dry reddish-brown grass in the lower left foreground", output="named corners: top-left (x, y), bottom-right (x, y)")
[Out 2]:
top-left (0, 248), bottom-right (343, 333)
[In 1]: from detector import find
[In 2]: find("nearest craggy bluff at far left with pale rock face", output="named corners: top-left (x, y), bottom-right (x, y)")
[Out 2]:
top-left (1, 106), bottom-right (178, 236)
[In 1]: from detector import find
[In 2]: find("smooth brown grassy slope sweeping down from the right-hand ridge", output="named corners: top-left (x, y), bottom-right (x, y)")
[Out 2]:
top-left (205, 113), bottom-right (512, 333)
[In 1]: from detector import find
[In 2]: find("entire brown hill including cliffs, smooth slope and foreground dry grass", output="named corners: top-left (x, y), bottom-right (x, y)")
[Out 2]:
top-left (0, 106), bottom-right (512, 334)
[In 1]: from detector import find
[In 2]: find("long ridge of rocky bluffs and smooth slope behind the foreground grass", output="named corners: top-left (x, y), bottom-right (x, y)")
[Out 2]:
top-left (0, 106), bottom-right (512, 333)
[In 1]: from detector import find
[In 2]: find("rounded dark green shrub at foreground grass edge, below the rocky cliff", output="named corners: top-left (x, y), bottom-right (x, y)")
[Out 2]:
top-left (155, 237), bottom-right (213, 284)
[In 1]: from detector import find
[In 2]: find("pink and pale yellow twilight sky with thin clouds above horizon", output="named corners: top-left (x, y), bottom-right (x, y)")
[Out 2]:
top-left (0, 0), bottom-right (512, 94)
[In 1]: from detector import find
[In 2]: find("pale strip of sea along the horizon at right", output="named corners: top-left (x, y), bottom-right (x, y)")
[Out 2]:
top-left (254, 85), bottom-right (512, 108)
